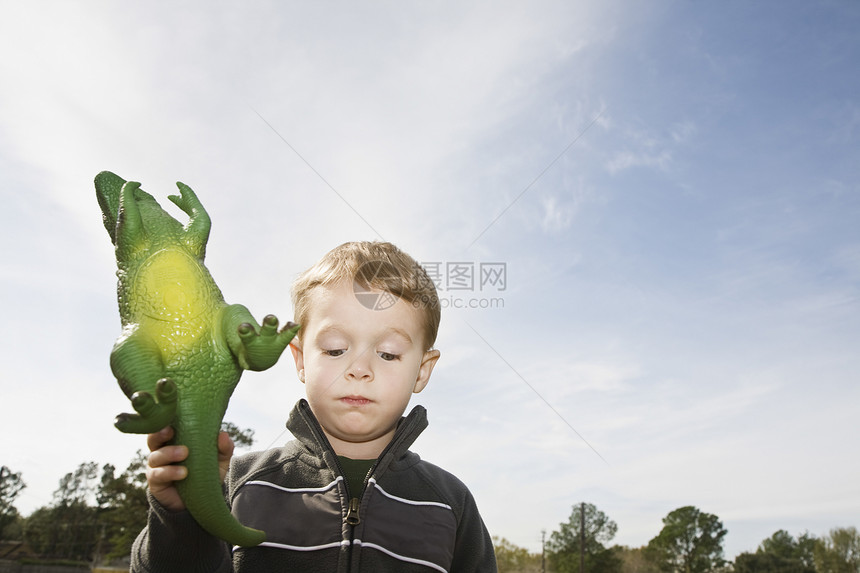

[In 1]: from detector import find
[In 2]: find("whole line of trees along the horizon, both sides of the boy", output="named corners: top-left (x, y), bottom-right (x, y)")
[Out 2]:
top-left (0, 456), bottom-right (860, 573)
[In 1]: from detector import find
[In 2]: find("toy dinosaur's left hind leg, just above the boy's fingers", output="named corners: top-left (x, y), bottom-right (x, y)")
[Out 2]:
top-left (110, 331), bottom-right (177, 434)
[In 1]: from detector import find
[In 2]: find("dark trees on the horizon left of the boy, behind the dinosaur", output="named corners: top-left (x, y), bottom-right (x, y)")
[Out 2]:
top-left (0, 422), bottom-right (254, 563)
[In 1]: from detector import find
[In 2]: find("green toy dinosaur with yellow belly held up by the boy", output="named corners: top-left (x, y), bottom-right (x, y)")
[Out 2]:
top-left (95, 171), bottom-right (299, 547)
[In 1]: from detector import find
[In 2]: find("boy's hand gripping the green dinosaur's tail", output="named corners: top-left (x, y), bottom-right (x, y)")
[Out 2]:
top-left (146, 426), bottom-right (233, 511)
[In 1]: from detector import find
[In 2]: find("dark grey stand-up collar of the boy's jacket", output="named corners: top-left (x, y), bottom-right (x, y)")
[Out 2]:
top-left (287, 398), bottom-right (428, 471)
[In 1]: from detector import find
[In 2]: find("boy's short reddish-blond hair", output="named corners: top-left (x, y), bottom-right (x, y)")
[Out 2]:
top-left (292, 241), bottom-right (441, 351)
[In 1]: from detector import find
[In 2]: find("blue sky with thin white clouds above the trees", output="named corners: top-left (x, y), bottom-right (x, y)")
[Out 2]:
top-left (0, 0), bottom-right (860, 558)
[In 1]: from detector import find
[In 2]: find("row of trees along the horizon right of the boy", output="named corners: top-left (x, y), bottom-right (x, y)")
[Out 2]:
top-left (493, 503), bottom-right (860, 573)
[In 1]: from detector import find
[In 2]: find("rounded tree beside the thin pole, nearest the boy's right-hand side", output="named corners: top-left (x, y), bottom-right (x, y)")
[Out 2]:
top-left (547, 503), bottom-right (621, 573)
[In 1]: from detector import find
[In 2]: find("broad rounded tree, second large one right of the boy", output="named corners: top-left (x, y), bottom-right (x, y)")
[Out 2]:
top-left (646, 506), bottom-right (727, 573)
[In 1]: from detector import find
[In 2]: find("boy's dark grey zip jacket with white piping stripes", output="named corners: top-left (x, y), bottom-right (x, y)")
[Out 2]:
top-left (131, 400), bottom-right (496, 573)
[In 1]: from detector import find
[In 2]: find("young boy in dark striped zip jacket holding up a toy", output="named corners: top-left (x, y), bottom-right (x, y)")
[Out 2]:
top-left (131, 242), bottom-right (496, 573)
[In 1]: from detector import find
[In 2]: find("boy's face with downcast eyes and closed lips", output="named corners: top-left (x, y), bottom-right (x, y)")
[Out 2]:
top-left (291, 281), bottom-right (439, 459)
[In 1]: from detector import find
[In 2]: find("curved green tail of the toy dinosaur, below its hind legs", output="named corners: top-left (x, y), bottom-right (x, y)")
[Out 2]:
top-left (176, 424), bottom-right (266, 547)
